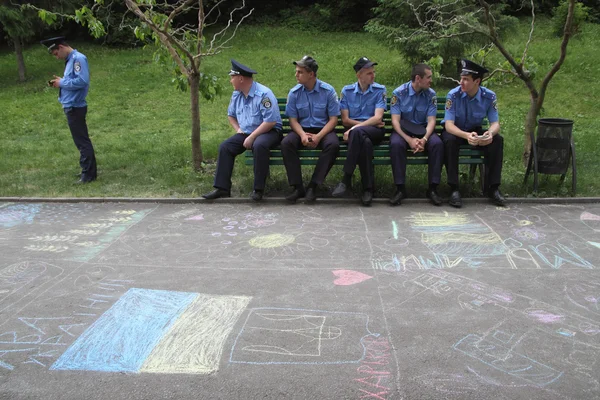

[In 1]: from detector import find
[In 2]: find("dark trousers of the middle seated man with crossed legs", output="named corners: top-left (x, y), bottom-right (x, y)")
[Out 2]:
top-left (344, 126), bottom-right (385, 190)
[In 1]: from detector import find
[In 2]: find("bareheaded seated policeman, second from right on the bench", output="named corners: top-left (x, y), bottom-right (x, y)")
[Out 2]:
top-left (390, 64), bottom-right (444, 206)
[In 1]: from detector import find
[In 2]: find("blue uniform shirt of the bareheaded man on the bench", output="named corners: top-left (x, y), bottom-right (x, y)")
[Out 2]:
top-left (390, 81), bottom-right (437, 126)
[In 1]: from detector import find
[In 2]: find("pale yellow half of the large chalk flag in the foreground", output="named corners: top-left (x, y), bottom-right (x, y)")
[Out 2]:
top-left (140, 294), bottom-right (251, 374)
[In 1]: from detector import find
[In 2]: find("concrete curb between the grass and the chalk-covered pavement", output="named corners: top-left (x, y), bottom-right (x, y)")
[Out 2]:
top-left (0, 197), bottom-right (600, 206)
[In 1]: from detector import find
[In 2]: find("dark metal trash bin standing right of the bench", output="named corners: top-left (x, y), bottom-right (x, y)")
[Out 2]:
top-left (523, 118), bottom-right (577, 196)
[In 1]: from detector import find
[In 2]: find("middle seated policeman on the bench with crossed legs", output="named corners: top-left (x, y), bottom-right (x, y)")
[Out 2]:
top-left (332, 57), bottom-right (387, 206)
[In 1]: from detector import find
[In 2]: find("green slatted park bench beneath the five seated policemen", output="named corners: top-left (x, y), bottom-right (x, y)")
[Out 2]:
top-left (244, 96), bottom-right (485, 191)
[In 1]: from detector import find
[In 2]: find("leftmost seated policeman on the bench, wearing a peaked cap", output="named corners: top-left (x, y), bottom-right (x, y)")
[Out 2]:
top-left (202, 60), bottom-right (281, 201)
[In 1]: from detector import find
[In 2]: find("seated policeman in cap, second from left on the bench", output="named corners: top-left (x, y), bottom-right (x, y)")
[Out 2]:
top-left (281, 56), bottom-right (340, 202)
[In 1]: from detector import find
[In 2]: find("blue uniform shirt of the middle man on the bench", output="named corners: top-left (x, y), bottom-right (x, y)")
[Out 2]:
top-left (340, 82), bottom-right (387, 121)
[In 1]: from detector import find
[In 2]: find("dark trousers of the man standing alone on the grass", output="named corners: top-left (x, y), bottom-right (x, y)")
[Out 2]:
top-left (64, 106), bottom-right (98, 182)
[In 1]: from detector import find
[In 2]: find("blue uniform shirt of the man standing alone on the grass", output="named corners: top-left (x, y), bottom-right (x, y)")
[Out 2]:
top-left (58, 49), bottom-right (90, 108)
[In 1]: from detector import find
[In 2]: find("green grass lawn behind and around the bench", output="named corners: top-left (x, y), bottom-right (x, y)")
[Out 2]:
top-left (0, 21), bottom-right (600, 197)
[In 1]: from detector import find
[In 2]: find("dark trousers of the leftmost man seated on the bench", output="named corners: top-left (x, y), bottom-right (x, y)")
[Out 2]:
top-left (214, 129), bottom-right (281, 190)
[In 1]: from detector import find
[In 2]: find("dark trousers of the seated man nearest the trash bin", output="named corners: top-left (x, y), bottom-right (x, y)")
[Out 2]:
top-left (442, 129), bottom-right (504, 190)
